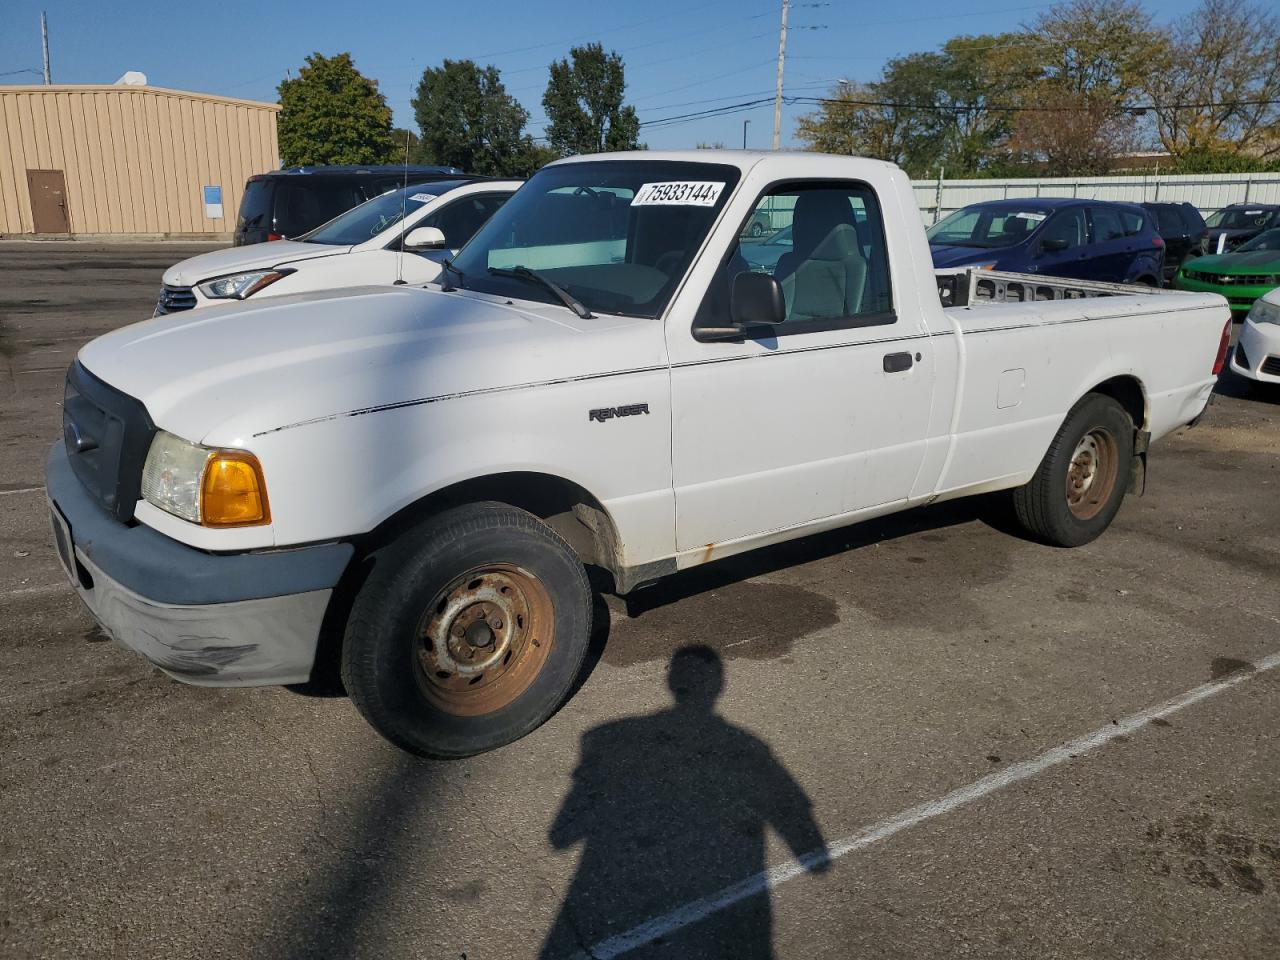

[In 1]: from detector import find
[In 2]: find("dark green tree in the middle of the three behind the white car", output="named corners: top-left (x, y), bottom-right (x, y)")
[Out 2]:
top-left (413, 60), bottom-right (538, 177)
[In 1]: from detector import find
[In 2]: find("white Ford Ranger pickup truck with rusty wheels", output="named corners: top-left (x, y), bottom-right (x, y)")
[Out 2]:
top-left (47, 151), bottom-right (1230, 756)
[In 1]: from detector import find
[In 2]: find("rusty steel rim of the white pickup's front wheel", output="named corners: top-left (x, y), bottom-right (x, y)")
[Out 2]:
top-left (417, 563), bottom-right (556, 717)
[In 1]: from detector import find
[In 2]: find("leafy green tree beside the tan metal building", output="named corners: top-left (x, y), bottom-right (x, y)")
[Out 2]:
top-left (276, 54), bottom-right (394, 166)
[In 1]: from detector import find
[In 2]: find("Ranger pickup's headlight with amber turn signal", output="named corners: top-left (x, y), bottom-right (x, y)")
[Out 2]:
top-left (142, 430), bottom-right (271, 526)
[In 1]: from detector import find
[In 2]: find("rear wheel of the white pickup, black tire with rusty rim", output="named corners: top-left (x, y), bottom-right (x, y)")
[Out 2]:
top-left (1014, 393), bottom-right (1134, 547)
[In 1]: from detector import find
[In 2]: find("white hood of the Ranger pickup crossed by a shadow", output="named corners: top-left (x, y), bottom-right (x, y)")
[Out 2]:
top-left (79, 287), bottom-right (666, 447)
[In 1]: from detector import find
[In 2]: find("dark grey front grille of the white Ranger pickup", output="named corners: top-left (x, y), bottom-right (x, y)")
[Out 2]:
top-left (63, 361), bottom-right (155, 522)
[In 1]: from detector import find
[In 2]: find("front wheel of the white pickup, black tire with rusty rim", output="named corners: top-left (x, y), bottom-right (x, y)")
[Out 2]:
top-left (342, 503), bottom-right (591, 759)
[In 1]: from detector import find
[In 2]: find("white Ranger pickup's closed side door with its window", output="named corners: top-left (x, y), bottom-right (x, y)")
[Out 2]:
top-left (667, 180), bottom-right (933, 563)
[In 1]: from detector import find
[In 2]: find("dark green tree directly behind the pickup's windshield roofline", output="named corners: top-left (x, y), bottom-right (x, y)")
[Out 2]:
top-left (543, 44), bottom-right (643, 156)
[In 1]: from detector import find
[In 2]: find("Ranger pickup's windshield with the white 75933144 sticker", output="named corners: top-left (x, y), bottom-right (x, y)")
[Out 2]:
top-left (449, 160), bottom-right (739, 317)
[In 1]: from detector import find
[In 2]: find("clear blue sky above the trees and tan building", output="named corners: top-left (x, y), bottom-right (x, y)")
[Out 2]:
top-left (0, 0), bottom-right (1197, 148)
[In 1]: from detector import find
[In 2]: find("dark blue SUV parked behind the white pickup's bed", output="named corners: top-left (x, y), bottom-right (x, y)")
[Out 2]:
top-left (928, 197), bottom-right (1165, 287)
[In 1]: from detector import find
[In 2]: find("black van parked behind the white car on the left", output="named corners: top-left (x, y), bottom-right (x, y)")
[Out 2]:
top-left (232, 165), bottom-right (465, 247)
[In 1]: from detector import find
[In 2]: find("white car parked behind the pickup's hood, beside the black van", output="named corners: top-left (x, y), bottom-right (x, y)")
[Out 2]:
top-left (155, 179), bottom-right (521, 316)
